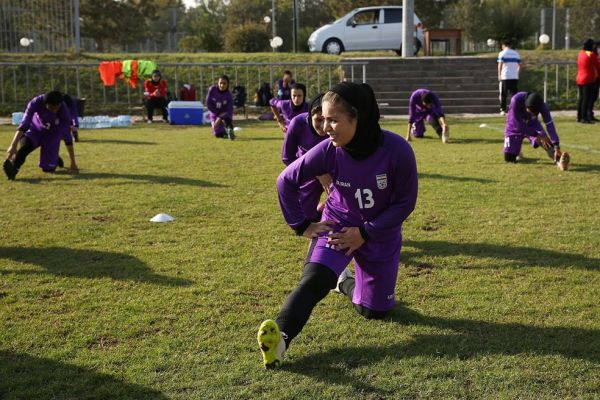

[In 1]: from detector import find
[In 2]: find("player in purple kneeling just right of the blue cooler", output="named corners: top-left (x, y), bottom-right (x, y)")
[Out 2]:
top-left (206, 75), bottom-right (235, 140)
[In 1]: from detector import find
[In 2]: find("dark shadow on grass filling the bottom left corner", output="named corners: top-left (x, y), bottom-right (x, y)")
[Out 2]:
top-left (0, 350), bottom-right (168, 400)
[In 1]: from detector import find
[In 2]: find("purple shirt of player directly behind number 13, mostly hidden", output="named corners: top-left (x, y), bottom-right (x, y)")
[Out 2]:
top-left (281, 112), bottom-right (329, 165)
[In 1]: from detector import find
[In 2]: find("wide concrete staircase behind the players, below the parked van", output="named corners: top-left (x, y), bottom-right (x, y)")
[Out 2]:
top-left (345, 57), bottom-right (500, 115)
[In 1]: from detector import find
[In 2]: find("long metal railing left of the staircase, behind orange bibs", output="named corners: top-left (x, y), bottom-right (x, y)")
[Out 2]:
top-left (0, 61), bottom-right (368, 114)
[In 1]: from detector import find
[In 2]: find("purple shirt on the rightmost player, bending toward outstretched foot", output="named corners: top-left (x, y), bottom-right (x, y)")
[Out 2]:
top-left (504, 92), bottom-right (560, 147)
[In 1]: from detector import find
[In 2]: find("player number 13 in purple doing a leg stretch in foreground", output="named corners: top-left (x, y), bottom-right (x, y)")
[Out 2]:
top-left (258, 82), bottom-right (417, 368)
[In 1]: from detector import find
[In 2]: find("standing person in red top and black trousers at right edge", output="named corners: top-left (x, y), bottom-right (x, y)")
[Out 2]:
top-left (576, 39), bottom-right (600, 124)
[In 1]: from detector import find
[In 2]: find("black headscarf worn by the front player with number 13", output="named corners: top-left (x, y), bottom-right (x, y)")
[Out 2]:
top-left (331, 82), bottom-right (383, 160)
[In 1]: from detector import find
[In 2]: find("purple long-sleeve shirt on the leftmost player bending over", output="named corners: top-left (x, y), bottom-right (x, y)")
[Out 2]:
top-left (18, 94), bottom-right (73, 146)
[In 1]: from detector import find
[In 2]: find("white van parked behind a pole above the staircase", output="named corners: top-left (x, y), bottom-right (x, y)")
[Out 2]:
top-left (308, 6), bottom-right (423, 55)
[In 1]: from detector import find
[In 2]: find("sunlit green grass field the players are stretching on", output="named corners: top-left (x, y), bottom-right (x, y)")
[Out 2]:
top-left (0, 117), bottom-right (600, 399)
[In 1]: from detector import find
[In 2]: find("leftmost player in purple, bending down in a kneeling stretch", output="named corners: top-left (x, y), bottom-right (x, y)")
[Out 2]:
top-left (2, 91), bottom-right (79, 180)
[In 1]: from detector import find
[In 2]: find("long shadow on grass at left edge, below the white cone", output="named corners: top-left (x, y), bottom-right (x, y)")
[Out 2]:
top-left (0, 247), bottom-right (192, 286)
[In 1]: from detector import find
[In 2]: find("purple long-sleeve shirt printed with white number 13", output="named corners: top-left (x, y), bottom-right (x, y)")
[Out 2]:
top-left (277, 131), bottom-right (418, 242)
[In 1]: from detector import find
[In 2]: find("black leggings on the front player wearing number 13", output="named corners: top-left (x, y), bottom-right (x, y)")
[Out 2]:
top-left (276, 262), bottom-right (387, 346)
